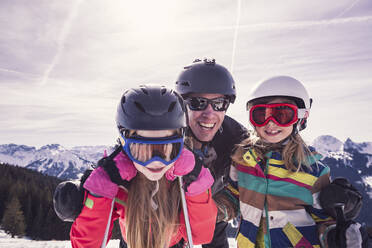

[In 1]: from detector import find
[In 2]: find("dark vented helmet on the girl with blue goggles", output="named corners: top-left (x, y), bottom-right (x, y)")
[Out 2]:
top-left (116, 84), bottom-right (186, 132)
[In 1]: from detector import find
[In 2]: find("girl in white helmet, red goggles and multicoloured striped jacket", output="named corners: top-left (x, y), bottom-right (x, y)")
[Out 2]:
top-left (227, 76), bottom-right (359, 248)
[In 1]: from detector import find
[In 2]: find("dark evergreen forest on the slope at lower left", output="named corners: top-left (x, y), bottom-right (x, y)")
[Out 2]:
top-left (0, 163), bottom-right (120, 240)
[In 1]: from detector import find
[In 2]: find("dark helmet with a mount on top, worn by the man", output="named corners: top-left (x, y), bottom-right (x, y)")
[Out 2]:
top-left (176, 59), bottom-right (236, 103)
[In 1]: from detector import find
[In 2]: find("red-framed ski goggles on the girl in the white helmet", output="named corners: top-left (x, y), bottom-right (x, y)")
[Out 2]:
top-left (249, 103), bottom-right (298, 127)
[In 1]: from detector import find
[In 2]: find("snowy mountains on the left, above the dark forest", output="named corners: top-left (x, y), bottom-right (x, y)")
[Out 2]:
top-left (0, 144), bottom-right (112, 179)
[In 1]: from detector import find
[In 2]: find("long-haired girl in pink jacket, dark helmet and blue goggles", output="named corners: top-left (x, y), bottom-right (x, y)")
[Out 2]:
top-left (70, 85), bottom-right (217, 248)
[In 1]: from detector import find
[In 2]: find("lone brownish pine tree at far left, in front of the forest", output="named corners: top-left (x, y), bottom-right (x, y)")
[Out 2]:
top-left (2, 196), bottom-right (26, 238)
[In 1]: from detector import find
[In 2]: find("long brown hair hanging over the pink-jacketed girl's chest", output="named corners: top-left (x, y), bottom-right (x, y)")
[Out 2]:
top-left (125, 173), bottom-right (180, 248)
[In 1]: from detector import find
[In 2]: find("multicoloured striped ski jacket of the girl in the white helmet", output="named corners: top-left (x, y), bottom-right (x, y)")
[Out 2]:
top-left (226, 150), bottom-right (330, 248)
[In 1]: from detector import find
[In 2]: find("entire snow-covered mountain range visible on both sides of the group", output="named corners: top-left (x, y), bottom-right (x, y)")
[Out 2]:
top-left (0, 135), bottom-right (372, 225)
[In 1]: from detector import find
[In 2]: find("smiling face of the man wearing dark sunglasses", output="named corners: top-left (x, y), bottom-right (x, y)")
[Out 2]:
top-left (187, 94), bottom-right (225, 142)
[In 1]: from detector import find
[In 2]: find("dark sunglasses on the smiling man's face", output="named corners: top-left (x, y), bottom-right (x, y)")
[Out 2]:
top-left (186, 97), bottom-right (230, 111)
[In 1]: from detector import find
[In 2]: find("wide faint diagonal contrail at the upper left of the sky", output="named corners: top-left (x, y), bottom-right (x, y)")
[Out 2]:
top-left (40, 0), bottom-right (84, 85)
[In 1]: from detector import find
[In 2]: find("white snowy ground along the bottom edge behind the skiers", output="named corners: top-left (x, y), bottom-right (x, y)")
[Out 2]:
top-left (0, 230), bottom-right (236, 248)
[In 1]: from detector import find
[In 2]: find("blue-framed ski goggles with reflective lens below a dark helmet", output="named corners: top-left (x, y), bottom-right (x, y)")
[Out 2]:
top-left (122, 135), bottom-right (183, 166)
